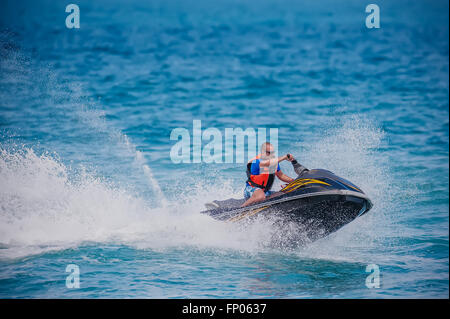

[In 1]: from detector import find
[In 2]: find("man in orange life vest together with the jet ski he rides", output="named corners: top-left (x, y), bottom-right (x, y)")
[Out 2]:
top-left (202, 142), bottom-right (372, 244)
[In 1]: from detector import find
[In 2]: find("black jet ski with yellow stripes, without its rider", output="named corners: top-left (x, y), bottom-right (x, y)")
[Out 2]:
top-left (202, 162), bottom-right (373, 242)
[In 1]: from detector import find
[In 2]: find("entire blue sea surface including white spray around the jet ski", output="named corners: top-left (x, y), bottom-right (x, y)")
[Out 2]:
top-left (0, 0), bottom-right (449, 298)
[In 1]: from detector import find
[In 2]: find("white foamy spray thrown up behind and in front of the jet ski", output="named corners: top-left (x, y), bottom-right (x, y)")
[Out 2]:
top-left (0, 115), bottom-right (391, 261)
